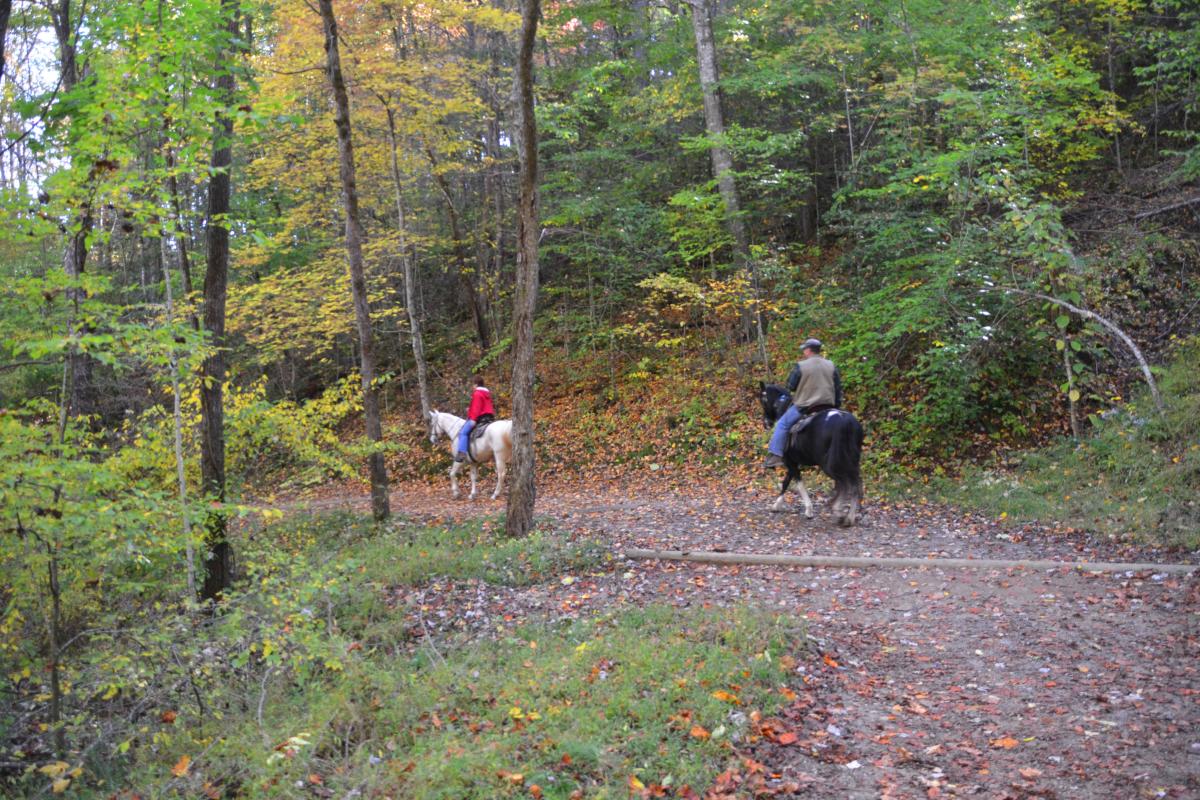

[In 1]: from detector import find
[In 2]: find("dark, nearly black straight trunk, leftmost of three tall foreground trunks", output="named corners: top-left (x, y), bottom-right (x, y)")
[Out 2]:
top-left (200, 0), bottom-right (238, 601)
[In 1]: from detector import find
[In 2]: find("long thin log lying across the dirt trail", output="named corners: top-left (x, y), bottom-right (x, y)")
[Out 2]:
top-left (624, 547), bottom-right (1200, 575)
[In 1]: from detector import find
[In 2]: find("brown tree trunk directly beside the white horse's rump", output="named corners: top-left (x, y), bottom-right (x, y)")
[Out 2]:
top-left (504, 0), bottom-right (541, 536)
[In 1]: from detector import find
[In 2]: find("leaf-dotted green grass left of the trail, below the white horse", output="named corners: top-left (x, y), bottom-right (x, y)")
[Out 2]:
top-left (25, 513), bottom-right (806, 799)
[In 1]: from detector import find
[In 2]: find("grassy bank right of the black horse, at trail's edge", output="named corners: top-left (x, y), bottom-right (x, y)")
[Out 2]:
top-left (930, 339), bottom-right (1200, 549)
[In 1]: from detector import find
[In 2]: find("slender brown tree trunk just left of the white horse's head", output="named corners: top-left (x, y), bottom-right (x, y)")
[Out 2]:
top-left (319, 0), bottom-right (390, 519)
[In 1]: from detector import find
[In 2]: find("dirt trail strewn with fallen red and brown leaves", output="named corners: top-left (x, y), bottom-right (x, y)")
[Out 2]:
top-left (292, 476), bottom-right (1200, 798)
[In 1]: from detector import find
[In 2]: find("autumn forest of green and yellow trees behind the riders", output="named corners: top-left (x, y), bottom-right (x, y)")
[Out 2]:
top-left (0, 0), bottom-right (1200, 786)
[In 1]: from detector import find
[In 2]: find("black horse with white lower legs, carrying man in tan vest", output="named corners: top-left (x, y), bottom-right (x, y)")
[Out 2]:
top-left (758, 381), bottom-right (863, 528)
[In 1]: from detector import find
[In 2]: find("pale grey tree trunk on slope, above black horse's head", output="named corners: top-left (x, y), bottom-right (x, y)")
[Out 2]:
top-left (689, 0), bottom-right (768, 369)
